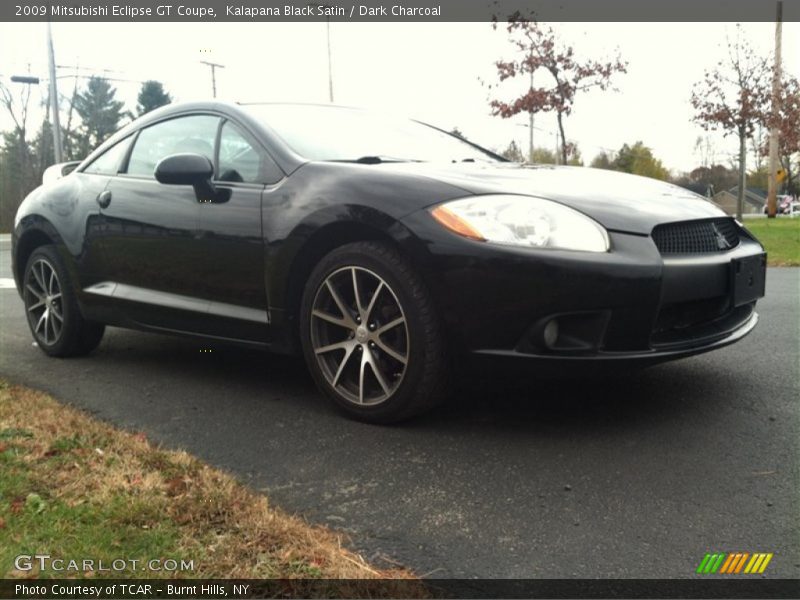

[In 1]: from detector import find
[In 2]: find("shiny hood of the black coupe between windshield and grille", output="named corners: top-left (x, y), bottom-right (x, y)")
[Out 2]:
top-left (376, 163), bottom-right (726, 234)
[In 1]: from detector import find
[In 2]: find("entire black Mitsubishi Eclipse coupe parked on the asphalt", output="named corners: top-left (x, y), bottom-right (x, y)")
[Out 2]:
top-left (12, 102), bottom-right (766, 422)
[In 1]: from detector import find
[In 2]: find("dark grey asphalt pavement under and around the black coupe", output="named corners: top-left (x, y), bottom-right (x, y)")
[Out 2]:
top-left (0, 242), bottom-right (800, 578)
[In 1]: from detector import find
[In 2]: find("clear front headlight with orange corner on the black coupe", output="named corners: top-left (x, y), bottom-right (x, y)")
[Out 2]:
top-left (431, 195), bottom-right (609, 252)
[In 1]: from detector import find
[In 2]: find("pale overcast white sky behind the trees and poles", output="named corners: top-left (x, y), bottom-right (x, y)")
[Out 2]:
top-left (0, 22), bottom-right (800, 173)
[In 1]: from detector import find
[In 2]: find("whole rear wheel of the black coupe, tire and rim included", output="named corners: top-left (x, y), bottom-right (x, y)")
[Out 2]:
top-left (22, 245), bottom-right (105, 357)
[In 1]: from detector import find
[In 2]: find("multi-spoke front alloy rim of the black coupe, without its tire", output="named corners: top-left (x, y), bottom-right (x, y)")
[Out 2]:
top-left (311, 266), bottom-right (409, 406)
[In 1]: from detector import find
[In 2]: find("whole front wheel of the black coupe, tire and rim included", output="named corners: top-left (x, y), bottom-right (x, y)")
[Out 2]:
top-left (300, 242), bottom-right (450, 424)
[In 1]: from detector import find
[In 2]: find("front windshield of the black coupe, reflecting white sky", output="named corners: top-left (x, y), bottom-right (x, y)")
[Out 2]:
top-left (244, 104), bottom-right (496, 163)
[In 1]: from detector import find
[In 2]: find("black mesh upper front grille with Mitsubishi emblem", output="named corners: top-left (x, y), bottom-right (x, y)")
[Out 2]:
top-left (653, 218), bottom-right (739, 254)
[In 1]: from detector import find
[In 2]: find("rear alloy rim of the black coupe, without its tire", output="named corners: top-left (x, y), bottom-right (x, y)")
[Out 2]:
top-left (24, 258), bottom-right (64, 346)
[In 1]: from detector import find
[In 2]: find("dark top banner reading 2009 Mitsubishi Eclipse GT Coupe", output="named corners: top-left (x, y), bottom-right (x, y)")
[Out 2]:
top-left (0, 0), bottom-right (800, 22)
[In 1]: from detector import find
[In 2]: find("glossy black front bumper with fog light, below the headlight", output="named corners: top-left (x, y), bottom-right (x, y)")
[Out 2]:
top-left (398, 213), bottom-right (765, 365)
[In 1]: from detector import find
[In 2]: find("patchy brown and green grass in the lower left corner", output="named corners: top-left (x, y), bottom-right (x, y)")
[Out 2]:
top-left (0, 379), bottom-right (422, 596)
